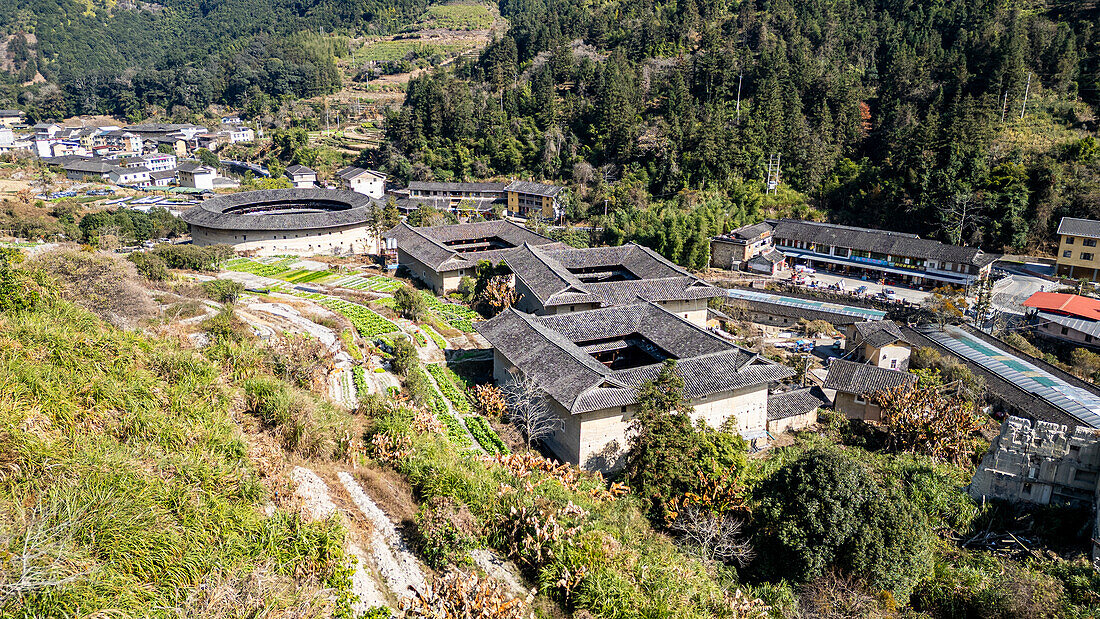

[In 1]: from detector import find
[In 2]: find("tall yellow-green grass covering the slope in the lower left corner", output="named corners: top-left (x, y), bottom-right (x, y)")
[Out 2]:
top-left (0, 295), bottom-right (348, 617)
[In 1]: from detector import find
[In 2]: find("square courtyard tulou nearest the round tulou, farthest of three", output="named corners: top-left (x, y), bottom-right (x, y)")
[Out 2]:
top-left (383, 220), bottom-right (562, 295)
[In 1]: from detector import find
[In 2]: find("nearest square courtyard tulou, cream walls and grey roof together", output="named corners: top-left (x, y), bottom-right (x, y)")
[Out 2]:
top-left (475, 302), bottom-right (794, 472)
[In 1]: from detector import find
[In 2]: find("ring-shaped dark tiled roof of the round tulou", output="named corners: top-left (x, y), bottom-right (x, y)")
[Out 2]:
top-left (182, 189), bottom-right (378, 231)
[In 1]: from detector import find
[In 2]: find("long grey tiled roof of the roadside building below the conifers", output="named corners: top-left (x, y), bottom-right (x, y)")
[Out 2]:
top-left (773, 219), bottom-right (997, 266)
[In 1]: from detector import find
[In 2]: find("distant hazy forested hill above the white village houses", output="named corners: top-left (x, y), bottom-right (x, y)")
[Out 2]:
top-left (0, 0), bottom-right (427, 119)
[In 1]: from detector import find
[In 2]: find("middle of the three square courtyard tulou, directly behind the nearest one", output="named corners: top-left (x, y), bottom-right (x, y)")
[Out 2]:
top-left (501, 243), bottom-right (726, 327)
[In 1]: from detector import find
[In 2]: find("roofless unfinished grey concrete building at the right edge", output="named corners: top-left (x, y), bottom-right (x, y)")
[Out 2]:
top-left (970, 417), bottom-right (1100, 568)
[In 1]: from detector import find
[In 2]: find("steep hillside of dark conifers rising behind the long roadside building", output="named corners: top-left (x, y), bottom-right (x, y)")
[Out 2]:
top-left (388, 0), bottom-right (1100, 248)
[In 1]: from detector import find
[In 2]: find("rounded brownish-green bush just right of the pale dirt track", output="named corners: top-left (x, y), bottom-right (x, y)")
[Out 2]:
top-left (416, 497), bottom-right (481, 570)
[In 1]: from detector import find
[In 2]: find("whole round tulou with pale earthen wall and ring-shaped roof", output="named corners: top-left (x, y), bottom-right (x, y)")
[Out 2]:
top-left (183, 189), bottom-right (378, 255)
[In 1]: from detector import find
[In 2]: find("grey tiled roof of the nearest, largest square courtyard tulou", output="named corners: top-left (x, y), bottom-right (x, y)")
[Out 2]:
top-left (475, 303), bottom-right (794, 413)
